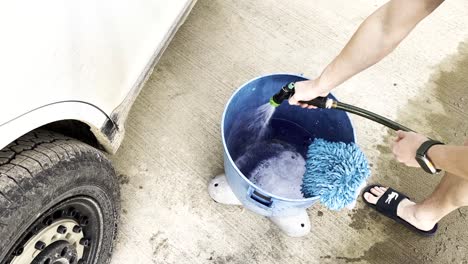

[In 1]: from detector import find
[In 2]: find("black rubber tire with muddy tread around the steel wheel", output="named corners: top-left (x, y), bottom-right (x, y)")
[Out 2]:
top-left (0, 130), bottom-right (119, 264)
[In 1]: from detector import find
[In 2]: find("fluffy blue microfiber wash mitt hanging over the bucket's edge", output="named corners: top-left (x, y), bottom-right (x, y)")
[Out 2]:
top-left (301, 139), bottom-right (370, 210)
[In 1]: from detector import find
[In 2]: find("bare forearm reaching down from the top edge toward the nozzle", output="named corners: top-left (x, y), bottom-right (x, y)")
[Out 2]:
top-left (319, 0), bottom-right (442, 90)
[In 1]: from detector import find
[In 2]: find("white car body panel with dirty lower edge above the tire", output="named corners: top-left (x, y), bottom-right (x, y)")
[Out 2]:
top-left (0, 0), bottom-right (195, 152)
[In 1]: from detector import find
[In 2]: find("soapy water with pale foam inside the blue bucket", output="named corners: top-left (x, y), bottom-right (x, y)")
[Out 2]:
top-left (229, 104), bottom-right (312, 199)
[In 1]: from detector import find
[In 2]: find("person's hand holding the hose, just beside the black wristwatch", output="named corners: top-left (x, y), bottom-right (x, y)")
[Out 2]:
top-left (392, 130), bottom-right (428, 167)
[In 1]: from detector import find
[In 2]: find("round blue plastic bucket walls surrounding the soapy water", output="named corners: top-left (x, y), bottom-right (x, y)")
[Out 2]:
top-left (221, 74), bottom-right (355, 216)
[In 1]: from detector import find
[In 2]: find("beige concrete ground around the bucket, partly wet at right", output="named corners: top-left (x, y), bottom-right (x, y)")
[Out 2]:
top-left (108, 0), bottom-right (468, 264)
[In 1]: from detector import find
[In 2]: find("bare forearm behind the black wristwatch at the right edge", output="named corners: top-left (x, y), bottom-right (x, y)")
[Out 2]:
top-left (427, 145), bottom-right (468, 179)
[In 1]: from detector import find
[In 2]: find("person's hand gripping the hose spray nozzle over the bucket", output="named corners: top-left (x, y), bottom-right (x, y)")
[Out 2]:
top-left (289, 79), bottom-right (330, 109)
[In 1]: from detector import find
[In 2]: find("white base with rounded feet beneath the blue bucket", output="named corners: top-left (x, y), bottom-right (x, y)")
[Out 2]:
top-left (208, 174), bottom-right (311, 237)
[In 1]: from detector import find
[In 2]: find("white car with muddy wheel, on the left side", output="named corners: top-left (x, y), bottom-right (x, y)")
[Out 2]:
top-left (0, 0), bottom-right (195, 264)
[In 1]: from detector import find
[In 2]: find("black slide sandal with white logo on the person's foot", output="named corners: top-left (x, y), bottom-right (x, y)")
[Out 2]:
top-left (362, 184), bottom-right (438, 236)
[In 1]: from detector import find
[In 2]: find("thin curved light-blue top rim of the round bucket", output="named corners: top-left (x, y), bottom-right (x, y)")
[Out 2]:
top-left (221, 72), bottom-right (357, 202)
